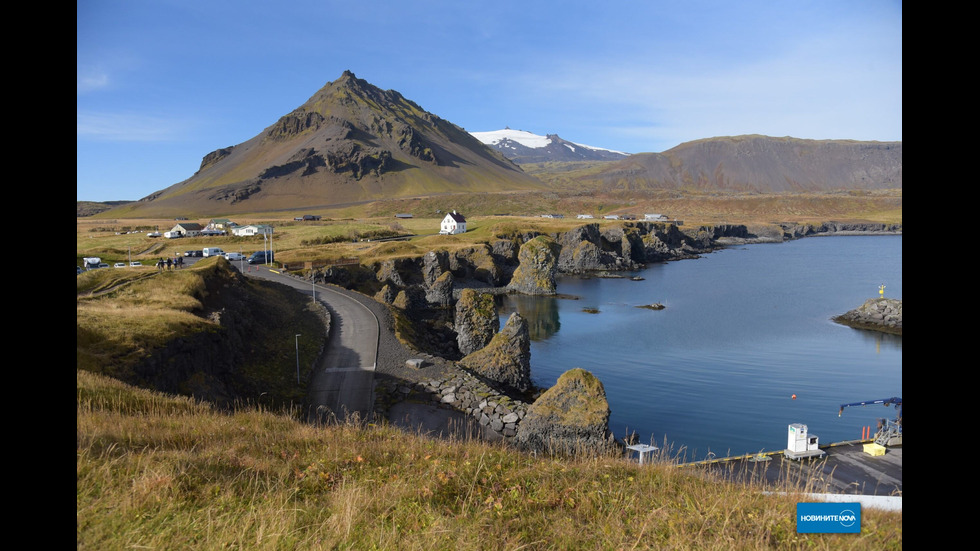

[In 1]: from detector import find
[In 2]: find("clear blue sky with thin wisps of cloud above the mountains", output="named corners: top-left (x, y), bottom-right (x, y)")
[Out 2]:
top-left (76, 0), bottom-right (902, 201)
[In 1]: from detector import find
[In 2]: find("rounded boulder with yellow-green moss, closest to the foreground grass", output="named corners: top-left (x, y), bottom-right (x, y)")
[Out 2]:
top-left (514, 368), bottom-right (616, 455)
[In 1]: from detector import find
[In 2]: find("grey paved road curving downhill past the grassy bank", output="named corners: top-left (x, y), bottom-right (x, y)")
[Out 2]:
top-left (232, 262), bottom-right (380, 421)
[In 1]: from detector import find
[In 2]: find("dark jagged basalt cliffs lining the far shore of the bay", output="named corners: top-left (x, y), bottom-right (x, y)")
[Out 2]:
top-left (308, 221), bottom-right (902, 360)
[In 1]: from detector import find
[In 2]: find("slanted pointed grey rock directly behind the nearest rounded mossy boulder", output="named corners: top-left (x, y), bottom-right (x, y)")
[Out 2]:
top-left (459, 312), bottom-right (531, 392)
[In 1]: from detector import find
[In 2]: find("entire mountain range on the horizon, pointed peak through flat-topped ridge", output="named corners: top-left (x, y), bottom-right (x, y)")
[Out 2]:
top-left (88, 71), bottom-right (902, 218)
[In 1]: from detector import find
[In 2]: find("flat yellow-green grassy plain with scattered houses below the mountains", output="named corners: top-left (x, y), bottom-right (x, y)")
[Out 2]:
top-left (76, 190), bottom-right (902, 265)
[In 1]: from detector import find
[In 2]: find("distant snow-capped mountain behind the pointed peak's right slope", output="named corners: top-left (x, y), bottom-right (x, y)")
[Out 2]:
top-left (470, 128), bottom-right (629, 164)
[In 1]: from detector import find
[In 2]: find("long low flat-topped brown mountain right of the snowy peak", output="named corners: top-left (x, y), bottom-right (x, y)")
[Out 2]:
top-left (574, 135), bottom-right (902, 193)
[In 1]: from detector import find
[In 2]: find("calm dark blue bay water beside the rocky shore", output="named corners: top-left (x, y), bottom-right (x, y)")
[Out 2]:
top-left (500, 236), bottom-right (902, 460)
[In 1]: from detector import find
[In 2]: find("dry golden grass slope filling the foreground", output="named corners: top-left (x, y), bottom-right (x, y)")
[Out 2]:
top-left (76, 370), bottom-right (902, 551)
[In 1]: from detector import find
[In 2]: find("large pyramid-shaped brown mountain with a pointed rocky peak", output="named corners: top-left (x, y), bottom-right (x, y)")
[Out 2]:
top-left (114, 71), bottom-right (543, 216)
